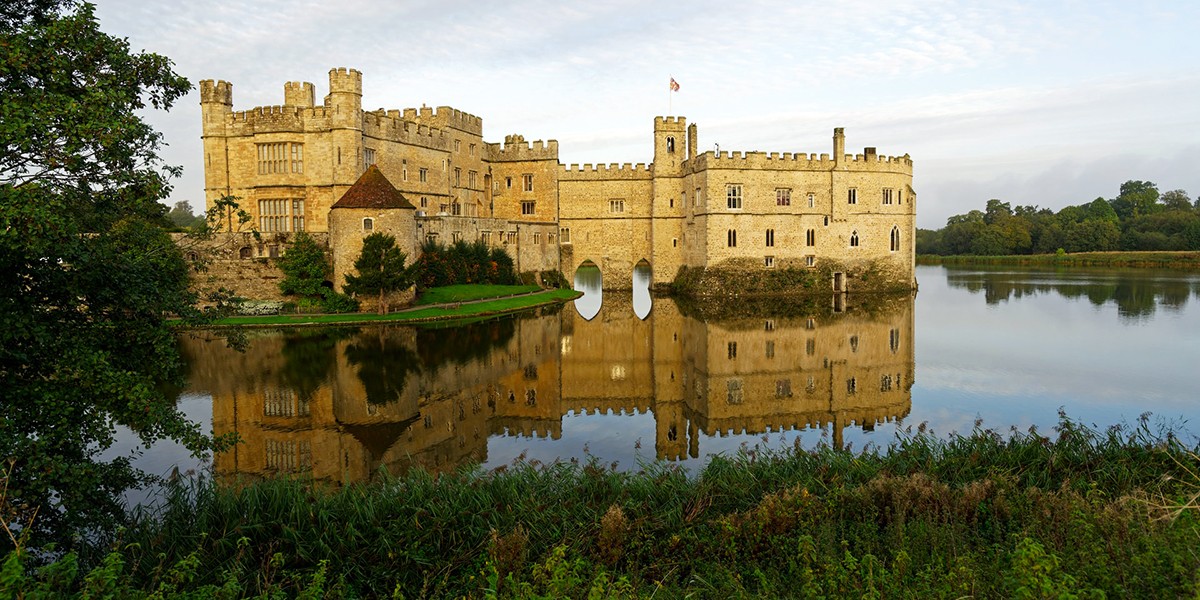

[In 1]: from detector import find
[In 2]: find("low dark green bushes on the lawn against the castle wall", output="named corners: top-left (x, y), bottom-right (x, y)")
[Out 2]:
top-left (416, 240), bottom-right (517, 289)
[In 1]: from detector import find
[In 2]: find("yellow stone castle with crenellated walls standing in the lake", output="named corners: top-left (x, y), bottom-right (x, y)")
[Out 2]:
top-left (200, 68), bottom-right (917, 292)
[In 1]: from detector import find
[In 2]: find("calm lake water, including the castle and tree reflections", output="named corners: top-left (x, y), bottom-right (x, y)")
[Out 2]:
top-left (150, 266), bottom-right (1200, 481)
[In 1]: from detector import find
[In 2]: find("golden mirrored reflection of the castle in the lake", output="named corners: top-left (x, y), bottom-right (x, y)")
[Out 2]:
top-left (181, 293), bottom-right (913, 481)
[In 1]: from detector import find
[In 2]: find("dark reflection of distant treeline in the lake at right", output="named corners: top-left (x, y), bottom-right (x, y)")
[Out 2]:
top-left (946, 266), bottom-right (1200, 322)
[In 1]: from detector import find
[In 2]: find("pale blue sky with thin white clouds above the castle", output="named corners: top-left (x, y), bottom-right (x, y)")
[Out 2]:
top-left (96, 0), bottom-right (1200, 228)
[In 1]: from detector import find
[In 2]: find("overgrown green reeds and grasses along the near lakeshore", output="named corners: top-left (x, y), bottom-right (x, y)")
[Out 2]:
top-left (0, 419), bottom-right (1200, 598)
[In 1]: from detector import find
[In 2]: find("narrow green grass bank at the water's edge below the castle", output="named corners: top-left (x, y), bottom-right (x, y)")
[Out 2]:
top-left (194, 286), bottom-right (582, 328)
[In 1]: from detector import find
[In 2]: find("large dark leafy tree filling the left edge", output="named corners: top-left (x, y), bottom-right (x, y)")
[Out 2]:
top-left (0, 0), bottom-right (225, 551)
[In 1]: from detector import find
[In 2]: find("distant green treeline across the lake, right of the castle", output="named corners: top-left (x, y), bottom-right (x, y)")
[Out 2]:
top-left (917, 181), bottom-right (1200, 256)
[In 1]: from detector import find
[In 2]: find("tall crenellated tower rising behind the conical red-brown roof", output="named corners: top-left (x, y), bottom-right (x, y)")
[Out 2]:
top-left (325, 67), bottom-right (365, 187)
